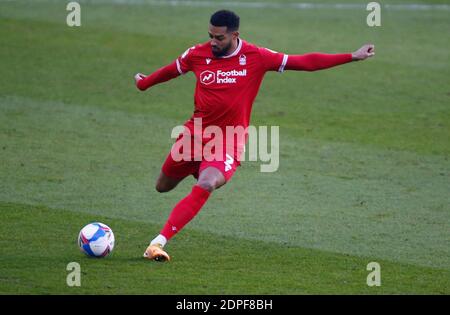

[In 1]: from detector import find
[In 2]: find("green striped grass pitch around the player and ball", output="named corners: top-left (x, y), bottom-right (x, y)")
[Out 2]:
top-left (0, 0), bottom-right (450, 294)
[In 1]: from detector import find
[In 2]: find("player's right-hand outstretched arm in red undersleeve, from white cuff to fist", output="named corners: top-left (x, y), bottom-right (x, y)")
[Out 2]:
top-left (285, 44), bottom-right (375, 71)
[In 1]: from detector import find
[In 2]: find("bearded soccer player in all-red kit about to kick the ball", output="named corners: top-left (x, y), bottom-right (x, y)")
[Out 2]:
top-left (134, 10), bottom-right (375, 261)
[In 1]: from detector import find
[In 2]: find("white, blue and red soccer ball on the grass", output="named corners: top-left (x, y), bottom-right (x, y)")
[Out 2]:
top-left (78, 222), bottom-right (114, 258)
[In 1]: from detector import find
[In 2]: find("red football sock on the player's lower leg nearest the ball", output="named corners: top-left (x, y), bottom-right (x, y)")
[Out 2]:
top-left (161, 185), bottom-right (211, 240)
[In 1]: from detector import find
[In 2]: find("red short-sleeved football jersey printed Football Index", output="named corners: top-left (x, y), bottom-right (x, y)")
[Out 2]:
top-left (176, 39), bottom-right (288, 158)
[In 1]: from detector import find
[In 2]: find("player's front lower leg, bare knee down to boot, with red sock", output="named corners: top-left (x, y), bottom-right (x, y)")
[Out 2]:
top-left (144, 167), bottom-right (226, 262)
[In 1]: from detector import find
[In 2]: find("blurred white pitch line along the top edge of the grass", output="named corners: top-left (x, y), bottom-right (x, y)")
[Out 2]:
top-left (0, 0), bottom-right (450, 11)
